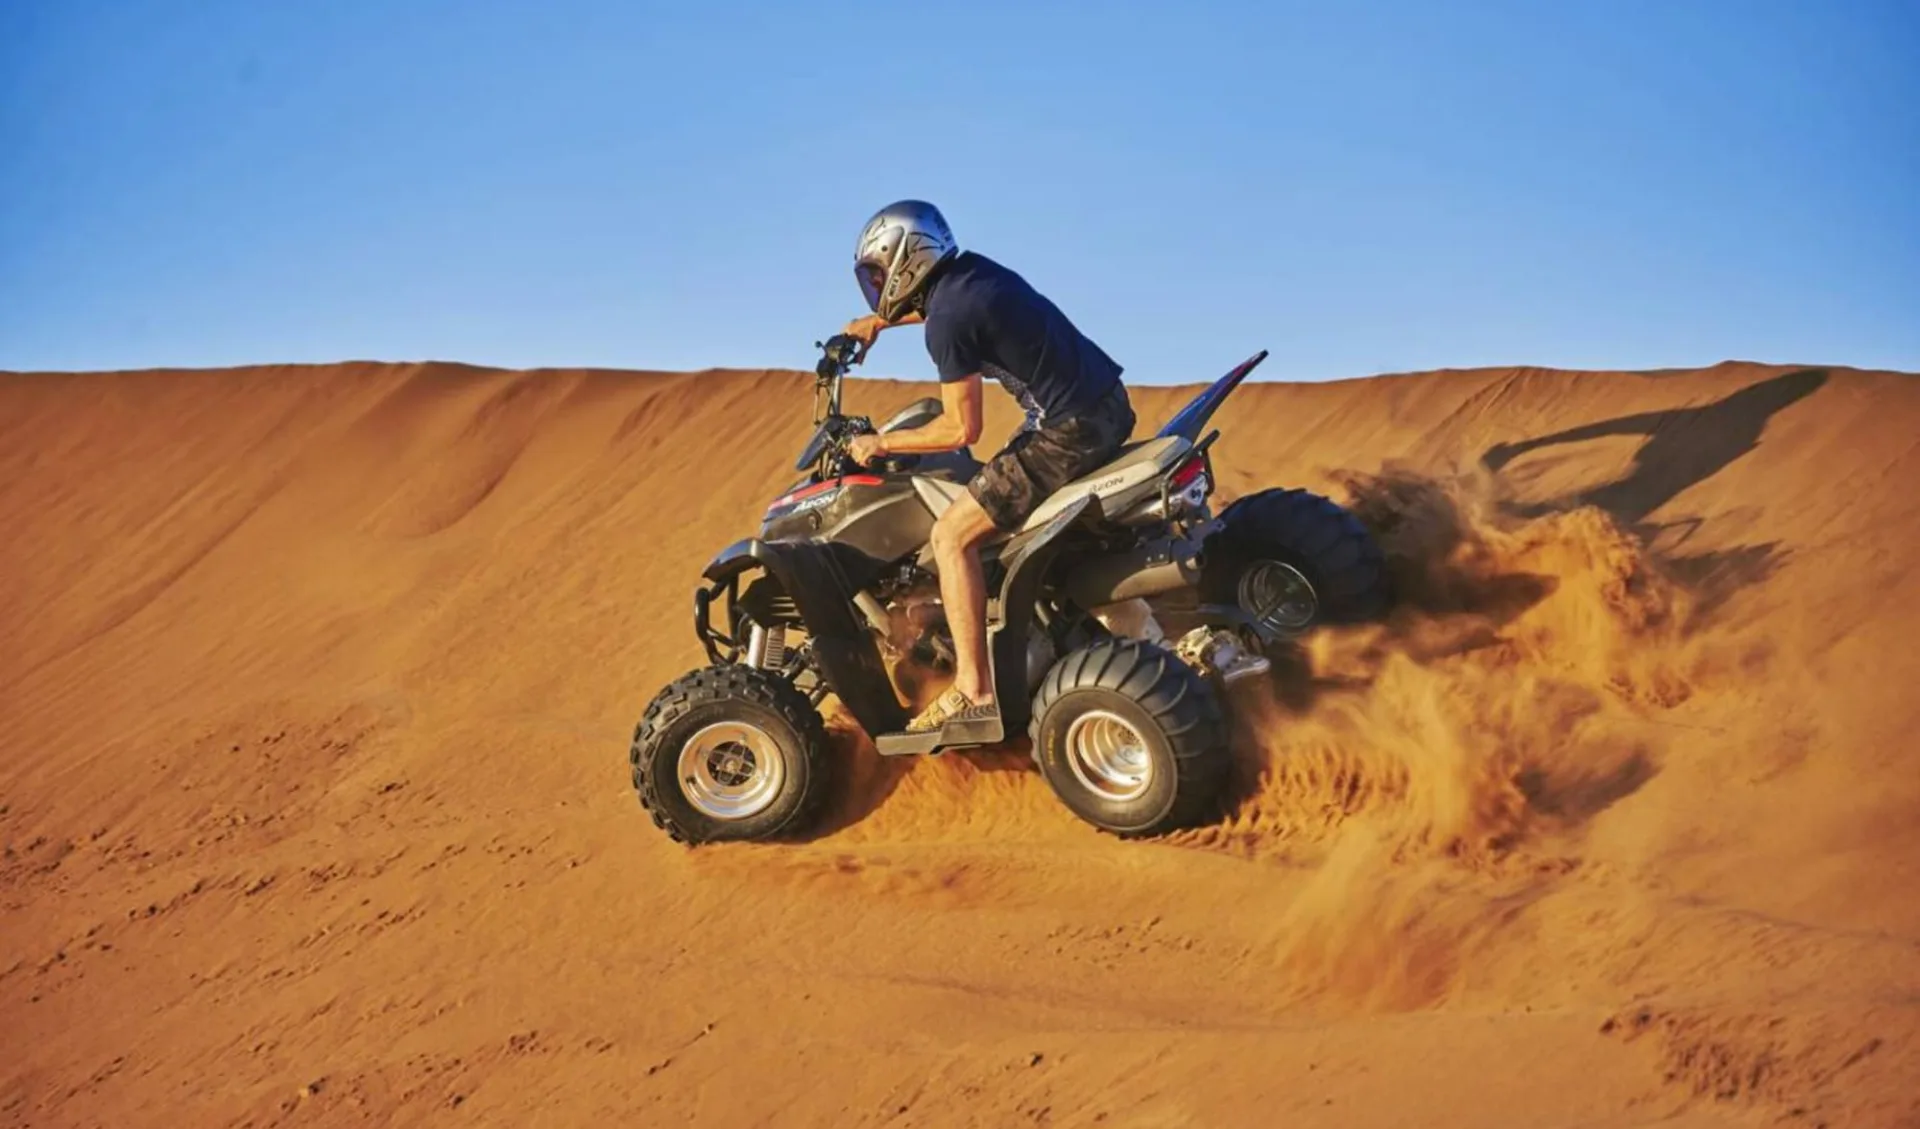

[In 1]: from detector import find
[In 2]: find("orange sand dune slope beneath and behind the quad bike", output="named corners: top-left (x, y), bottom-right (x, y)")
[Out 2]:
top-left (0, 357), bottom-right (1920, 1127)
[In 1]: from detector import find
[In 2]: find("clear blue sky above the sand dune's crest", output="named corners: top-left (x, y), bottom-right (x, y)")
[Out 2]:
top-left (0, 0), bottom-right (1920, 382)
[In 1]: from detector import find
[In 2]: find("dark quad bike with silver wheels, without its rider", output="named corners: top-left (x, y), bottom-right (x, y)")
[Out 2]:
top-left (630, 336), bottom-right (1388, 843)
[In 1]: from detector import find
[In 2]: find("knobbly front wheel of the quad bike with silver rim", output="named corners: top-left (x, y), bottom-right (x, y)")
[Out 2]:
top-left (630, 666), bottom-right (831, 843)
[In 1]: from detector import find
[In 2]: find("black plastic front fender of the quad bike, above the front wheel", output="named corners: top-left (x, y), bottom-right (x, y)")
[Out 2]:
top-left (693, 538), bottom-right (906, 733)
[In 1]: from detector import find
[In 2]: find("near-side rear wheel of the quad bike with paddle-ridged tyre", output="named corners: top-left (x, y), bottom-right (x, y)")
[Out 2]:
top-left (1029, 639), bottom-right (1231, 839)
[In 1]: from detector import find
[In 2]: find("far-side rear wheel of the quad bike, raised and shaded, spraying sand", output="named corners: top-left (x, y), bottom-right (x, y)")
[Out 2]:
top-left (1200, 490), bottom-right (1392, 639)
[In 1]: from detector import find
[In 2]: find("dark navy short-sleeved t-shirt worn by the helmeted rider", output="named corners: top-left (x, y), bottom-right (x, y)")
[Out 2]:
top-left (925, 252), bottom-right (1121, 424)
